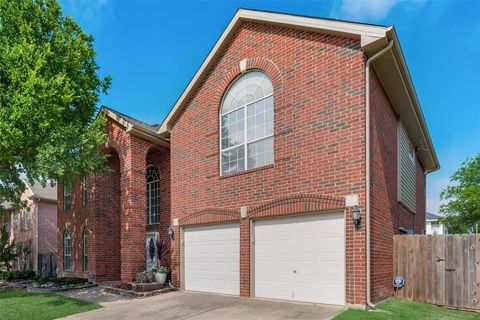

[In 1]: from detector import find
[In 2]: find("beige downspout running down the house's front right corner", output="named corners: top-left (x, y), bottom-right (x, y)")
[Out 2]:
top-left (365, 40), bottom-right (393, 309)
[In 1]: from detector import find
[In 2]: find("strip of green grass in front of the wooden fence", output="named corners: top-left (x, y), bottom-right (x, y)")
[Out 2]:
top-left (335, 299), bottom-right (480, 320)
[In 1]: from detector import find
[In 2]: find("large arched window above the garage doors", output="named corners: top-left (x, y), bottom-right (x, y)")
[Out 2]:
top-left (220, 71), bottom-right (273, 175)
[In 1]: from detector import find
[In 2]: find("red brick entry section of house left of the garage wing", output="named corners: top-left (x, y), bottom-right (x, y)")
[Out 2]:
top-left (57, 119), bottom-right (170, 281)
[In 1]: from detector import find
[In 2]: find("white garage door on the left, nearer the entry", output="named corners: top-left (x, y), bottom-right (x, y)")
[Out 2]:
top-left (184, 223), bottom-right (240, 295)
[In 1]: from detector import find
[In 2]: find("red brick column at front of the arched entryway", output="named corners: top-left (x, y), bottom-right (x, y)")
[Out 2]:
top-left (120, 136), bottom-right (146, 281)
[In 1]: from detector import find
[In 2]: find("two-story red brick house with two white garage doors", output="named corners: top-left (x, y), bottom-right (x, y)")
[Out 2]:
top-left (58, 10), bottom-right (439, 305)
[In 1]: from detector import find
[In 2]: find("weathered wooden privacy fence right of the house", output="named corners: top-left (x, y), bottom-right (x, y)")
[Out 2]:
top-left (393, 235), bottom-right (480, 309)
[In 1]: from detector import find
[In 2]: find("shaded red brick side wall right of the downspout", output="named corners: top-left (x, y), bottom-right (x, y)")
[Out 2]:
top-left (370, 72), bottom-right (425, 301)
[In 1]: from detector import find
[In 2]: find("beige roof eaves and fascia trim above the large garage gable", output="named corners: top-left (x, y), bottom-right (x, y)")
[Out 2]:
top-left (157, 9), bottom-right (440, 173)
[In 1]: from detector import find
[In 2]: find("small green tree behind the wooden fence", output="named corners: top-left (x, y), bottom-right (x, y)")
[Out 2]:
top-left (440, 154), bottom-right (480, 233)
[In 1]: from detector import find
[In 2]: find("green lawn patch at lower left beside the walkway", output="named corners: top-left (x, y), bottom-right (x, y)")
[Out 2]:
top-left (0, 290), bottom-right (100, 320)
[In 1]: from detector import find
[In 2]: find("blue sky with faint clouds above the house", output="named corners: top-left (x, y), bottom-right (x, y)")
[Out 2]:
top-left (60, 0), bottom-right (480, 213)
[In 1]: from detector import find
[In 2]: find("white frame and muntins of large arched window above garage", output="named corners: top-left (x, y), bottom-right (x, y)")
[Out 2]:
top-left (218, 69), bottom-right (275, 177)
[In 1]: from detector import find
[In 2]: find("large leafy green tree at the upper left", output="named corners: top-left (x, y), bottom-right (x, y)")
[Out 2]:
top-left (0, 0), bottom-right (110, 203)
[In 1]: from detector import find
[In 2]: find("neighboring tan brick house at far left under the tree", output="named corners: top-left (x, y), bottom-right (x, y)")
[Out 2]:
top-left (0, 180), bottom-right (58, 272)
